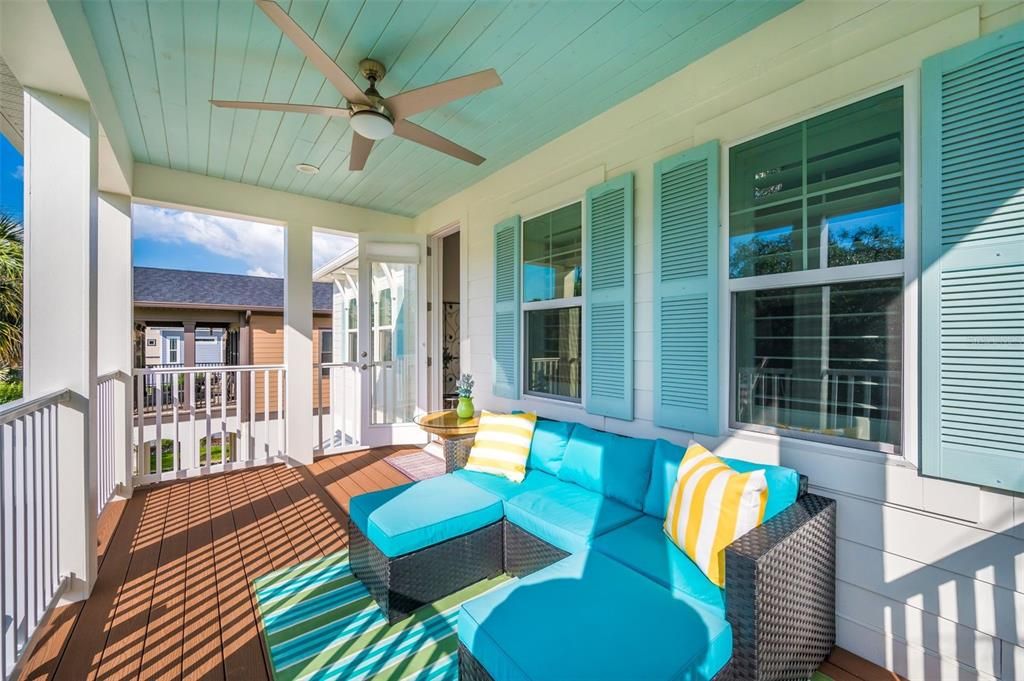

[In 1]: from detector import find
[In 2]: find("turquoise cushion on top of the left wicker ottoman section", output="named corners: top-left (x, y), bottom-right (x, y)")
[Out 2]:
top-left (349, 475), bottom-right (503, 558)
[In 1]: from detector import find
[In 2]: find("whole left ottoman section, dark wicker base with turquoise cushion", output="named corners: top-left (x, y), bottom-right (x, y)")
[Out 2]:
top-left (348, 475), bottom-right (504, 623)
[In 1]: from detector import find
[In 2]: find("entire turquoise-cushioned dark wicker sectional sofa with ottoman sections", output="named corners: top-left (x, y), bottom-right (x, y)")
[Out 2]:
top-left (349, 420), bottom-right (835, 681)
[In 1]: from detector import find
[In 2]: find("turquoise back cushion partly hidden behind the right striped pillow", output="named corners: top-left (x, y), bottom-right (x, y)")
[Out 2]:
top-left (643, 439), bottom-right (800, 520)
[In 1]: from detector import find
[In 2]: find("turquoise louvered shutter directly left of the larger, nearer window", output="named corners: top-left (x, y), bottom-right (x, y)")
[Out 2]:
top-left (654, 141), bottom-right (720, 435)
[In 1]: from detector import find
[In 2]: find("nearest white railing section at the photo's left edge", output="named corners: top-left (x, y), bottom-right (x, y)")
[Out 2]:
top-left (0, 390), bottom-right (71, 679)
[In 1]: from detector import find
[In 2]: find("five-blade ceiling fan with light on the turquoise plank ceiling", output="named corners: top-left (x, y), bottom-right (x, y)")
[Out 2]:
top-left (210, 0), bottom-right (502, 170)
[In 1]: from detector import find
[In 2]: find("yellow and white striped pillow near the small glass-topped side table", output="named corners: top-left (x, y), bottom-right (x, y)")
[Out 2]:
top-left (466, 412), bottom-right (537, 482)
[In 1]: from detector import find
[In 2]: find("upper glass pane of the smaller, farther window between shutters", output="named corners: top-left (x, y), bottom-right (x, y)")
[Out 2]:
top-left (522, 203), bottom-right (583, 302)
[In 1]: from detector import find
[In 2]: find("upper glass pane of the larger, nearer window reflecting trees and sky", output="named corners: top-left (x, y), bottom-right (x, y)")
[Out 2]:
top-left (729, 88), bottom-right (903, 279)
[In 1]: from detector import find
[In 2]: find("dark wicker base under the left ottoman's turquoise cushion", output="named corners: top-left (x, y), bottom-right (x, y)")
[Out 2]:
top-left (348, 520), bottom-right (503, 624)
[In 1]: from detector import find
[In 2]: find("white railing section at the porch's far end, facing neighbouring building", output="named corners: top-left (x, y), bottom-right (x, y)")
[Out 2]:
top-left (133, 365), bottom-right (287, 484)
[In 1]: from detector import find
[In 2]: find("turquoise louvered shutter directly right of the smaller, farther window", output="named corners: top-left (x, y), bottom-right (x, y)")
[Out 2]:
top-left (583, 173), bottom-right (633, 421)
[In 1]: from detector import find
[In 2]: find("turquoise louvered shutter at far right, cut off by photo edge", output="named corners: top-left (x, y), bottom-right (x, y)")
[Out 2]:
top-left (921, 25), bottom-right (1024, 492)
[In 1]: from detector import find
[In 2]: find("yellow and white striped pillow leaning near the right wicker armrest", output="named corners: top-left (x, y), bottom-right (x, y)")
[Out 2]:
top-left (665, 441), bottom-right (768, 587)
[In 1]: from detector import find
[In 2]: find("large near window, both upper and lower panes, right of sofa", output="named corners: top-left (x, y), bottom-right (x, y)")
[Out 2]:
top-left (729, 89), bottom-right (904, 452)
